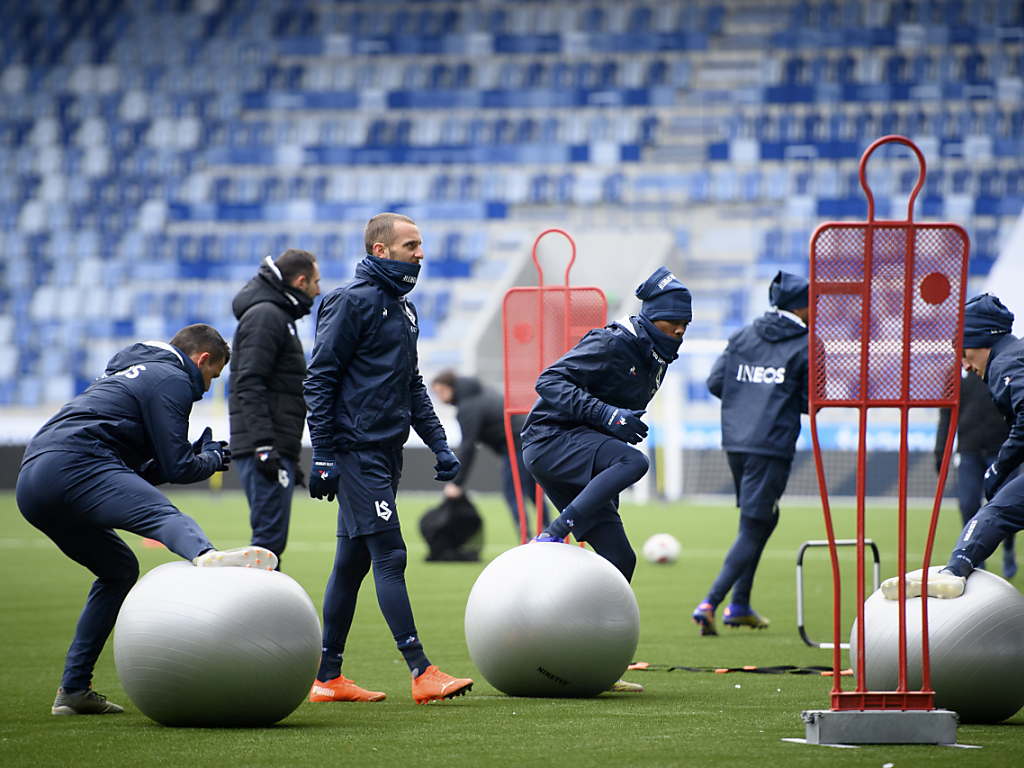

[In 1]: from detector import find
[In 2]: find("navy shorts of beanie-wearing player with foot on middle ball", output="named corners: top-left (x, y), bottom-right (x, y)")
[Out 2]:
top-left (522, 427), bottom-right (618, 542)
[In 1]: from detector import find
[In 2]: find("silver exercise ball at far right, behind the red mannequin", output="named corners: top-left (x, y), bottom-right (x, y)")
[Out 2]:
top-left (850, 568), bottom-right (1024, 723)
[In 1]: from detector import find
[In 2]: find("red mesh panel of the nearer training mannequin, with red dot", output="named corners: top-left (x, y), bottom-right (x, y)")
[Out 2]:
top-left (811, 223), bottom-right (967, 406)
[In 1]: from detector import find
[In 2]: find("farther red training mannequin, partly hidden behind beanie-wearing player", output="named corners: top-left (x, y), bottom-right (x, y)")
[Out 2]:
top-left (502, 228), bottom-right (608, 544)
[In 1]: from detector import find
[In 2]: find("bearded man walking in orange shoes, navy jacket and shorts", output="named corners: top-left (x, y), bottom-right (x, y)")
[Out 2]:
top-left (305, 213), bottom-right (473, 703)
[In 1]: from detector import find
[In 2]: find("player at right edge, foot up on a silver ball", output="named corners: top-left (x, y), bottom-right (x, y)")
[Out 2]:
top-left (882, 293), bottom-right (1024, 600)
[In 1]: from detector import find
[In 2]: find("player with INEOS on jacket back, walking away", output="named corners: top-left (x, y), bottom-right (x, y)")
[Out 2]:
top-left (693, 270), bottom-right (809, 635)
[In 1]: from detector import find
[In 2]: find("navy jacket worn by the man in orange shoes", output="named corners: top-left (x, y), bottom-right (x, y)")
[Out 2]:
top-left (305, 263), bottom-right (446, 451)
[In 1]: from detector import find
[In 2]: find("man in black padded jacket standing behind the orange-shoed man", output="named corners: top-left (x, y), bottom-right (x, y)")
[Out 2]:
top-left (228, 248), bottom-right (319, 558)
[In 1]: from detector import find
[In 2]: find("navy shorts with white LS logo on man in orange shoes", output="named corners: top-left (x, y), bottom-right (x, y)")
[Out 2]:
top-left (334, 447), bottom-right (402, 539)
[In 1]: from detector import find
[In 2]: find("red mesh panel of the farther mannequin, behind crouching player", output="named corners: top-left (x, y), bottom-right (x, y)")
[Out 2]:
top-left (502, 286), bottom-right (607, 413)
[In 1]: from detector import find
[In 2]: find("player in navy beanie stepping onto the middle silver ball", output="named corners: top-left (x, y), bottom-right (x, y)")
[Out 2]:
top-left (522, 266), bottom-right (693, 692)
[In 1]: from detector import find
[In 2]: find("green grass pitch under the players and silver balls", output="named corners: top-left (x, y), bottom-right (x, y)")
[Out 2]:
top-left (0, 490), bottom-right (1024, 768)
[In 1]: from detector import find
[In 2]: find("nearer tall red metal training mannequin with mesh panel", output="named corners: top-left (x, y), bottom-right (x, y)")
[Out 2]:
top-left (809, 136), bottom-right (970, 710)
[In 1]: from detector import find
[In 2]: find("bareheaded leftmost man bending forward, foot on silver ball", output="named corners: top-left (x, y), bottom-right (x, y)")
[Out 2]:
top-left (16, 325), bottom-right (276, 715)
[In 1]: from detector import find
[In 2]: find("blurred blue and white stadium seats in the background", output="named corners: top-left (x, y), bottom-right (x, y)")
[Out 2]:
top-left (0, 0), bottom-right (1024, 407)
